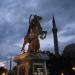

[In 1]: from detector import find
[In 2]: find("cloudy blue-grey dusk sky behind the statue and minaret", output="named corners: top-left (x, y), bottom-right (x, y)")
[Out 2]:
top-left (0, 0), bottom-right (75, 68)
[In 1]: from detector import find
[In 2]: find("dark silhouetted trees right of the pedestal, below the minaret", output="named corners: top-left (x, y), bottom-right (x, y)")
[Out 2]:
top-left (47, 44), bottom-right (75, 75)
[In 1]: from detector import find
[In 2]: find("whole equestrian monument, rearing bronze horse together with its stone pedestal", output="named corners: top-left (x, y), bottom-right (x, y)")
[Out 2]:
top-left (14, 15), bottom-right (49, 75)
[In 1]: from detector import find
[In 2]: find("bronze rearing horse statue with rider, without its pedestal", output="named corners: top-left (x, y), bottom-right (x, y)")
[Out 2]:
top-left (21, 15), bottom-right (47, 53)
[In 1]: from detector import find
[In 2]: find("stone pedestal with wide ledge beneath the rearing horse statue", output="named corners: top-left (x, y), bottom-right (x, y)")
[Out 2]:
top-left (14, 52), bottom-right (49, 75)
